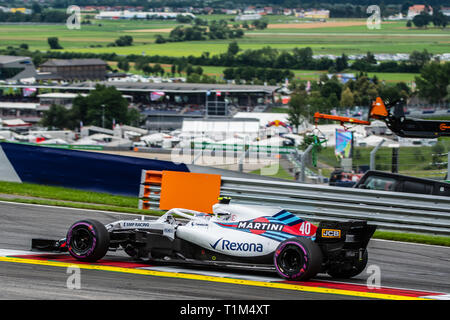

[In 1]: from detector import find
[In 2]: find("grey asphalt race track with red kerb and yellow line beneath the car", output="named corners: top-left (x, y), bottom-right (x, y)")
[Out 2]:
top-left (0, 202), bottom-right (450, 300)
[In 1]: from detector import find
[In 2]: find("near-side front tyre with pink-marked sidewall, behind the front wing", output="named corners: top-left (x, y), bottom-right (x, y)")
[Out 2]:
top-left (66, 219), bottom-right (109, 262)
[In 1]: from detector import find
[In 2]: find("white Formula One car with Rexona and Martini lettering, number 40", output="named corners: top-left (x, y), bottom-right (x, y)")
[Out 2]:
top-left (32, 199), bottom-right (376, 280)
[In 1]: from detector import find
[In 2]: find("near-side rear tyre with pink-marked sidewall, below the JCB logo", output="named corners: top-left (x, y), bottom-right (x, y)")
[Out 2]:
top-left (273, 238), bottom-right (322, 281)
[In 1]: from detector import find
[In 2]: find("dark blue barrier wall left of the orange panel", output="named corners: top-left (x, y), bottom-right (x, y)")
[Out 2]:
top-left (0, 142), bottom-right (189, 197)
